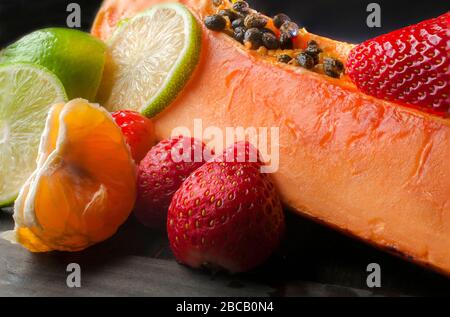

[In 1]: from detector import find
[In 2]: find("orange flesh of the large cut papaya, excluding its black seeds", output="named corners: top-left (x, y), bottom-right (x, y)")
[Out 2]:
top-left (92, 0), bottom-right (450, 275)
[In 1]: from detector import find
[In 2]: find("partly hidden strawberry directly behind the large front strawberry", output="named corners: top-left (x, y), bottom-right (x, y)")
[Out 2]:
top-left (135, 136), bottom-right (212, 228)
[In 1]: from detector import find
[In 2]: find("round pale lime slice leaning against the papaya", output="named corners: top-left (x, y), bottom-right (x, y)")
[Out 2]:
top-left (98, 3), bottom-right (201, 117)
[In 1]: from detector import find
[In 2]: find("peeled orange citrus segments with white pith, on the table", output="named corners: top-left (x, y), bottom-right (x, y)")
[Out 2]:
top-left (4, 99), bottom-right (136, 252)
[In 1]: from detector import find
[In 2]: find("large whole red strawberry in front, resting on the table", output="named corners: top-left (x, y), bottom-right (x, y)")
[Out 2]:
top-left (167, 161), bottom-right (285, 273)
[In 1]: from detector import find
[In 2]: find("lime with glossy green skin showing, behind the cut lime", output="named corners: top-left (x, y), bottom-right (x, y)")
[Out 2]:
top-left (0, 28), bottom-right (106, 100)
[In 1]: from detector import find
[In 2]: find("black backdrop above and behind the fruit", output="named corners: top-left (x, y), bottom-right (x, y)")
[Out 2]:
top-left (0, 0), bottom-right (450, 46)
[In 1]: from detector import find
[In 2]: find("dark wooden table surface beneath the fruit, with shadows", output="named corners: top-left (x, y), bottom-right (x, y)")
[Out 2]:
top-left (0, 206), bottom-right (450, 296)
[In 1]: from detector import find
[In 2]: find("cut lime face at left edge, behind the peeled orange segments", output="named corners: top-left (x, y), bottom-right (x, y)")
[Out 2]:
top-left (0, 63), bottom-right (67, 207)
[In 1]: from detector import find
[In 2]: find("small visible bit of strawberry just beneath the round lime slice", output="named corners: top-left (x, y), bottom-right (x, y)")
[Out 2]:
top-left (112, 110), bottom-right (155, 164)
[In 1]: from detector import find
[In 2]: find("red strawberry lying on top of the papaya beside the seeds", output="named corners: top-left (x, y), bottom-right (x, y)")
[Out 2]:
top-left (347, 13), bottom-right (450, 115)
